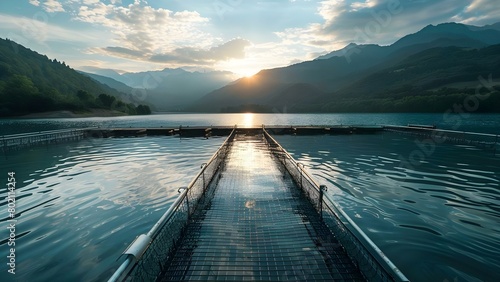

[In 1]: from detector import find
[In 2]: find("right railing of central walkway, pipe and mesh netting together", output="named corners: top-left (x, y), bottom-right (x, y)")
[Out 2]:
top-left (264, 129), bottom-right (409, 281)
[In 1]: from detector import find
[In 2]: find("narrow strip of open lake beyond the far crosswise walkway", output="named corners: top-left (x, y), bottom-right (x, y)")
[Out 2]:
top-left (0, 113), bottom-right (500, 135)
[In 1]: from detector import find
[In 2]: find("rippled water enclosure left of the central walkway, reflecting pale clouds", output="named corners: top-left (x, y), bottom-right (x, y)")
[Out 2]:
top-left (0, 137), bottom-right (223, 281)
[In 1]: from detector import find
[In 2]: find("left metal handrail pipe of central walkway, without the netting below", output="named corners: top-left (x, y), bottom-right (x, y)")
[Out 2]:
top-left (108, 128), bottom-right (236, 282)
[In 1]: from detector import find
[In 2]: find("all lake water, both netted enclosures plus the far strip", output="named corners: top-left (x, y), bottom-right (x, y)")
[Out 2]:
top-left (0, 113), bottom-right (500, 281)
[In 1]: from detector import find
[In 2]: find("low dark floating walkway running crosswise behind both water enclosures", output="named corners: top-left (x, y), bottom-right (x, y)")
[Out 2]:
top-left (0, 124), bottom-right (500, 154)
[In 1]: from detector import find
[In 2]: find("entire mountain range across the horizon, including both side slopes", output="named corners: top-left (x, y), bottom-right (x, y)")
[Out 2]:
top-left (0, 20), bottom-right (500, 116)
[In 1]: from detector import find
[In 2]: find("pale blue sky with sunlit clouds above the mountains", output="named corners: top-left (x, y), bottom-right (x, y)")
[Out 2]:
top-left (0, 0), bottom-right (500, 75)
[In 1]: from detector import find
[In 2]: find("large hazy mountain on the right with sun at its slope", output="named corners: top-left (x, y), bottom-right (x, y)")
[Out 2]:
top-left (189, 23), bottom-right (500, 112)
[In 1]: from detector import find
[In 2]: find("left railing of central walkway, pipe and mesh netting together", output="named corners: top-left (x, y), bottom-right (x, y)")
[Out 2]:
top-left (108, 129), bottom-right (236, 282)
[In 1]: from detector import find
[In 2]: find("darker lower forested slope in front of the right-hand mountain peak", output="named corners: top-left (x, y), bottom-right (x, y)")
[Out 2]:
top-left (312, 45), bottom-right (500, 112)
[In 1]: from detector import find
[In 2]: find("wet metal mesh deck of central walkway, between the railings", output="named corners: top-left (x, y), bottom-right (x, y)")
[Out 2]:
top-left (162, 135), bottom-right (364, 281)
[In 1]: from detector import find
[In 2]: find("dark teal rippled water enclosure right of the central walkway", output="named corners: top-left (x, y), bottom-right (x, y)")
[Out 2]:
top-left (277, 133), bottom-right (500, 281)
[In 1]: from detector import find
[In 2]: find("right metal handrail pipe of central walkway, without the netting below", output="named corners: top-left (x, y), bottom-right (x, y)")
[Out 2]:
top-left (263, 128), bottom-right (409, 281)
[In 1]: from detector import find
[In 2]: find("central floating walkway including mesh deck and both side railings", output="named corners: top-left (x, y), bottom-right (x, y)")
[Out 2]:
top-left (109, 129), bottom-right (407, 281)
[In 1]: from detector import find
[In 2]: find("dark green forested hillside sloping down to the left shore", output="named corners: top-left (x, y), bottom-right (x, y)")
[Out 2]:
top-left (0, 39), bottom-right (151, 116)
